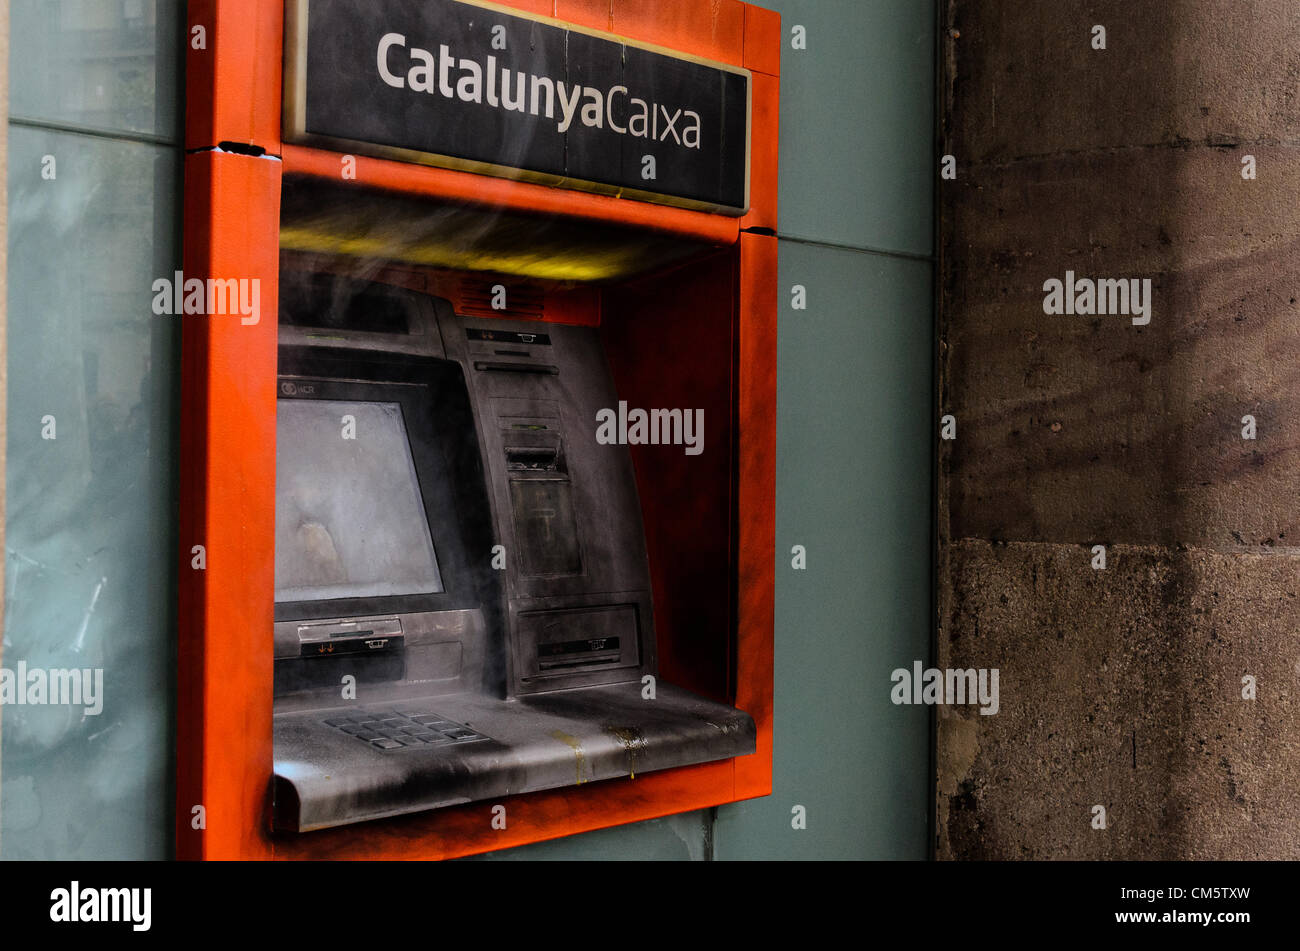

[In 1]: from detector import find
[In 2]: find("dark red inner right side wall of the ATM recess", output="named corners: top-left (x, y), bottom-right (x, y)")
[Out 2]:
top-left (601, 252), bottom-right (741, 702)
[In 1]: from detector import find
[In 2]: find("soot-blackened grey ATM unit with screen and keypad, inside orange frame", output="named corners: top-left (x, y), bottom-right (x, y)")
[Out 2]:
top-left (272, 270), bottom-right (755, 833)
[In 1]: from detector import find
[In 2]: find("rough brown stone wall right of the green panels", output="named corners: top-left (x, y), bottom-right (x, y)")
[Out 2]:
top-left (936, 0), bottom-right (1300, 859)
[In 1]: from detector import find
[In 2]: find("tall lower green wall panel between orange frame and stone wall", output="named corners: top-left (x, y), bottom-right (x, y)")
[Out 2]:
top-left (715, 242), bottom-right (933, 859)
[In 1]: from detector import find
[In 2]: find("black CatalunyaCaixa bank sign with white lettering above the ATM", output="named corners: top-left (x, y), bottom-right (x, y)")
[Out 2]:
top-left (285, 0), bottom-right (750, 216)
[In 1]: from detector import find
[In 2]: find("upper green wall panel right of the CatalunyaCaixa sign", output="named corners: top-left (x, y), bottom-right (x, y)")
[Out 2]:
top-left (762, 0), bottom-right (937, 255)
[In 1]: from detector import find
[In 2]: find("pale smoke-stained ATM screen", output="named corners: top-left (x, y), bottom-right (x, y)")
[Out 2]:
top-left (276, 399), bottom-right (443, 602)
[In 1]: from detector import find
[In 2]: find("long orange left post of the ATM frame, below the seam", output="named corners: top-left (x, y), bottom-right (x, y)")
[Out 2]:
top-left (172, 152), bottom-right (280, 859)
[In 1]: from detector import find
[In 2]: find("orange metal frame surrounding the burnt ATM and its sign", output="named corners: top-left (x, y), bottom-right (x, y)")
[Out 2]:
top-left (176, 0), bottom-right (781, 859)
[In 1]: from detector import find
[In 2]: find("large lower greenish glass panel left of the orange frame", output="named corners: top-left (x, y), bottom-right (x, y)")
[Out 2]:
top-left (0, 126), bottom-right (181, 859)
